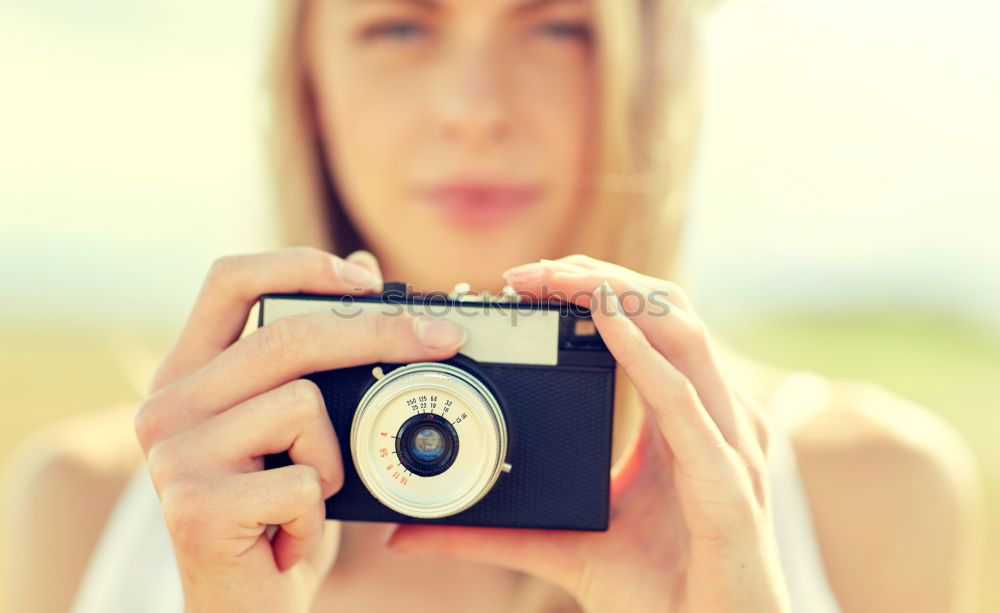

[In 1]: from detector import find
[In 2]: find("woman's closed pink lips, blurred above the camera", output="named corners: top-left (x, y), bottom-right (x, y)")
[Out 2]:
top-left (423, 183), bottom-right (540, 225)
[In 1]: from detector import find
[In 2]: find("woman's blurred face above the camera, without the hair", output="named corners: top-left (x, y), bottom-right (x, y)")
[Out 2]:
top-left (306, 0), bottom-right (596, 290)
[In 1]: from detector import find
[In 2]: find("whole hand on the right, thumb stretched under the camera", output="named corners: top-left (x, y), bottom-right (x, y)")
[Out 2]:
top-left (389, 255), bottom-right (789, 613)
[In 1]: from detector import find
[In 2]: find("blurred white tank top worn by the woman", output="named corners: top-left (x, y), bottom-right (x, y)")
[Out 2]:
top-left (72, 372), bottom-right (840, 613)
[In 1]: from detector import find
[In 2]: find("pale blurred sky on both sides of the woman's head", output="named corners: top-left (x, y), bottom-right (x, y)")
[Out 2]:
top-left (0, 0), bottom-right (1000, 327)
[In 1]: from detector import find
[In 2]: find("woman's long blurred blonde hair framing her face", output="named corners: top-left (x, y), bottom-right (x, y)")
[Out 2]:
top-left (268, 0), bottom-right (703, 611)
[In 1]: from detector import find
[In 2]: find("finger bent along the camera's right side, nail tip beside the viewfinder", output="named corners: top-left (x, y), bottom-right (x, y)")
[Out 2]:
top-left (592, 282), bottom-right (728, 475)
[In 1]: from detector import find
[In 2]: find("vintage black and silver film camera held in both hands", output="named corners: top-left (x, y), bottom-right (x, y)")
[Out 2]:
top-left (258, 283), bottom-right (615, 531)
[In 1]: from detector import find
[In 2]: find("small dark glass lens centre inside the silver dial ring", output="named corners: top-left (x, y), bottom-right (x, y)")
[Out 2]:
top-left (396, 413), bottom-right (458, 477)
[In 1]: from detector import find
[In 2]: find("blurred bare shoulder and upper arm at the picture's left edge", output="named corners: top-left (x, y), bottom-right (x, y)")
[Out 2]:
top-left (0, 407), bottom-right (142, 611)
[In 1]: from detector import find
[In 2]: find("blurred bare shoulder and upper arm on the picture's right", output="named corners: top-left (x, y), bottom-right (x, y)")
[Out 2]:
top-left (792, 380), bottom-right (981, 612)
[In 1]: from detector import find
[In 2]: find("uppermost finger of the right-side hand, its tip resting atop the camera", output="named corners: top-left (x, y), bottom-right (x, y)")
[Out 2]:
top-left (504, 261), bottom-right (754, 453)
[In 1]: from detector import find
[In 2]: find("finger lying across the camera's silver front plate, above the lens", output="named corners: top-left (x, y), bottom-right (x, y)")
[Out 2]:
top-left (135, 311), bottom-right (465, 449)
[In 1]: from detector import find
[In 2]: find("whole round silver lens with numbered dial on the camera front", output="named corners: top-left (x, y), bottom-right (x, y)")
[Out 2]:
top-left (351, 362), bottom-right (507, 519)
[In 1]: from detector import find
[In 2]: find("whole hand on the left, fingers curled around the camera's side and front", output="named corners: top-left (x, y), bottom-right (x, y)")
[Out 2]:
top-left (135, 248), bottom-right (472, 612)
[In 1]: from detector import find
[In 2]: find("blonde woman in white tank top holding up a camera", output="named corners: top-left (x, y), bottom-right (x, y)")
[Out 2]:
top-left (1, 0), bottom-right (977, 612)
